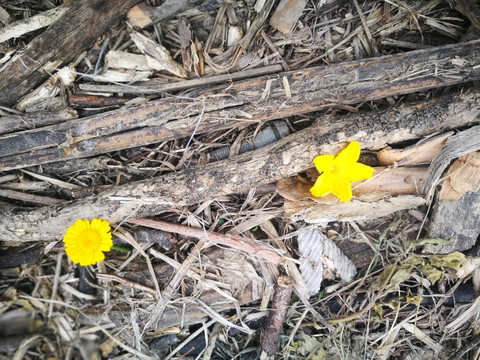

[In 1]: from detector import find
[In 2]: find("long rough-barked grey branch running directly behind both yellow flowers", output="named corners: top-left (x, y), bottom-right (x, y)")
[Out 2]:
top-left (0, 89), bottom-right (480, 242)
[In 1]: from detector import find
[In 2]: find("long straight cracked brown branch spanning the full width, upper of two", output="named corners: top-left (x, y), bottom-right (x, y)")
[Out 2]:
top-left (0, 41), bottom-right (480, 171)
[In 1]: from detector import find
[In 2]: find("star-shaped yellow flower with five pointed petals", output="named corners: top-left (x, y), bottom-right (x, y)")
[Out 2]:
top-left (310, 141), bottom-right (373, 202)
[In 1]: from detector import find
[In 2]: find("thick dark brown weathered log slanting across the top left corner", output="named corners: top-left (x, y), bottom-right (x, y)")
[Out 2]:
top-left (0, 0), bottom-right (139, 106)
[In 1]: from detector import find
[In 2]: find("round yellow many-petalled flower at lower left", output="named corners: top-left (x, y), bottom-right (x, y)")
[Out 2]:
top-left (63, 219), bottom-right (113, 266)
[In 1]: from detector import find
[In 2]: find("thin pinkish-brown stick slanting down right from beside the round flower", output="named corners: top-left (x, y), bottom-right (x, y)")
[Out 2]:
top-left (127, 219), bottom-right (286, 264)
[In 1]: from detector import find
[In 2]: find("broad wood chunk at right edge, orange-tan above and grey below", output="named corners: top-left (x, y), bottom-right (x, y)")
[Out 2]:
top-left (424, 152), bottom-right (480, 254)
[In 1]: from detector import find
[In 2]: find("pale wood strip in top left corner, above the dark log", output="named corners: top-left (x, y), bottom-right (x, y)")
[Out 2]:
top-left (0, 5), bottom-right (68, 43)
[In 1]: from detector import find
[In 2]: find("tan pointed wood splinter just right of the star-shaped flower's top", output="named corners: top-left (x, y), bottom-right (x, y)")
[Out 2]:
top-left (377, 132), bottom-right (453, 166)
